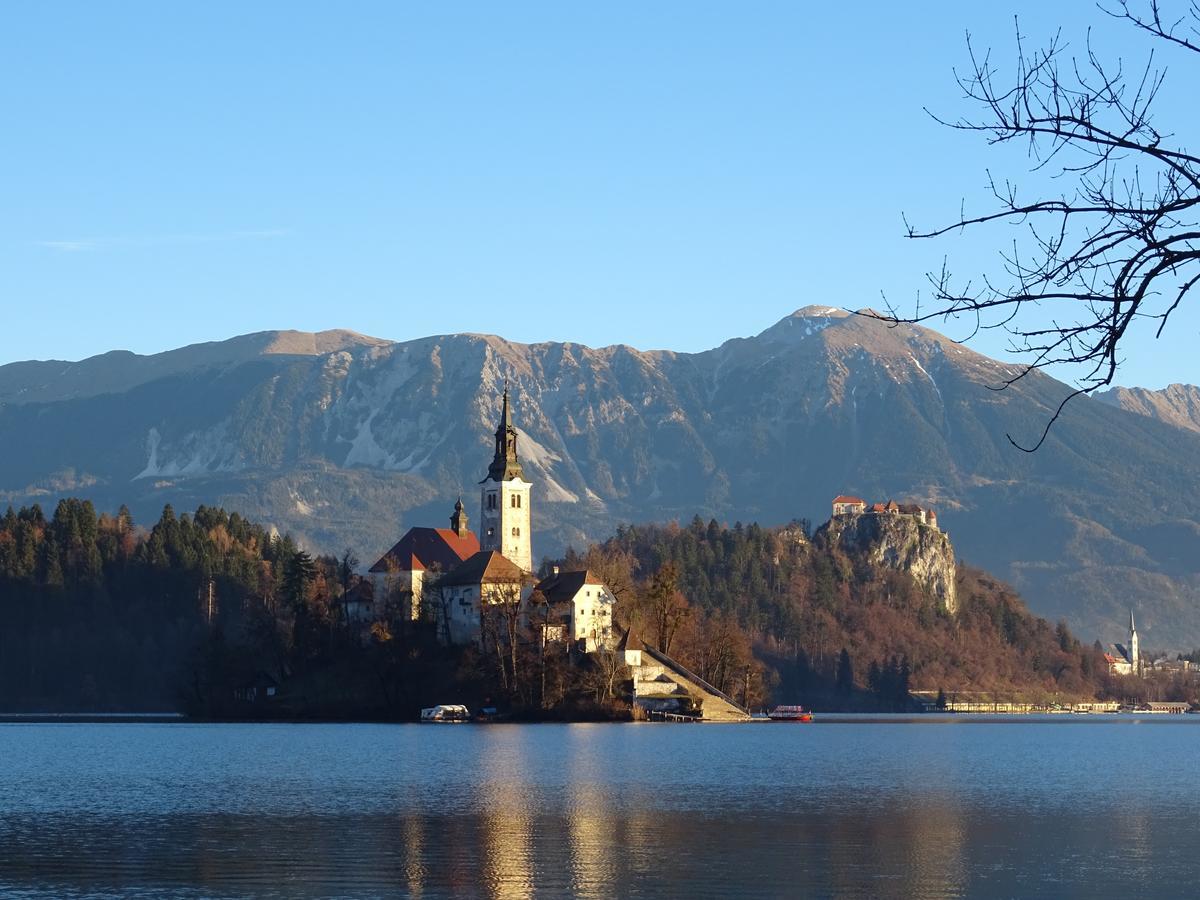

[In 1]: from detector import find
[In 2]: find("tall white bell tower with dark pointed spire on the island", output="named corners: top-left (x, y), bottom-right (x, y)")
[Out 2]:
top-left (479, 382), bottom-right (533, 572)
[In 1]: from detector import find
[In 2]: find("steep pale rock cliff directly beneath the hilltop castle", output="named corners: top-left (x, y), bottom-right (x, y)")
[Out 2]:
top-left (817, 512), bottom-right (959, 614)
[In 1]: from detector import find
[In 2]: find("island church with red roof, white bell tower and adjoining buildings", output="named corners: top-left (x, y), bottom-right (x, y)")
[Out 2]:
top-left (359, 384), bottom-right (616, 653)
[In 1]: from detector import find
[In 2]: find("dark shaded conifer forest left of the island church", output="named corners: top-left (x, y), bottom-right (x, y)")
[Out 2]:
top-left (0, 499), bottom-right (360, 710)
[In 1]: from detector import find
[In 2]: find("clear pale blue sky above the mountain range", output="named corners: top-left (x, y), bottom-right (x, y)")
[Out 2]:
top-left (0, 0), bottom-right (1200, 386)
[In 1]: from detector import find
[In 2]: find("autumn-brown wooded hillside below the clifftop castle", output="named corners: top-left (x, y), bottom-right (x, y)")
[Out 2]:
top-left (569, 517), bottom-right (1108, 707)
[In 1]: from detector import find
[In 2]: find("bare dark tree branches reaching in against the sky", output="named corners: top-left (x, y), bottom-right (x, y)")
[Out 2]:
top-left (886, 0), bottom-right (1200, 451)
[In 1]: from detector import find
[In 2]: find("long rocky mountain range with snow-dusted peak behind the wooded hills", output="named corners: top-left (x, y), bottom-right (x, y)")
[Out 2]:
top-left (0, 307), bottom-right (1200, 647)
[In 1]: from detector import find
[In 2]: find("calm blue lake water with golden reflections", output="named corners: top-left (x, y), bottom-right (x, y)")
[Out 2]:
top-left (0, 716), bottom-right (1200, 898)
